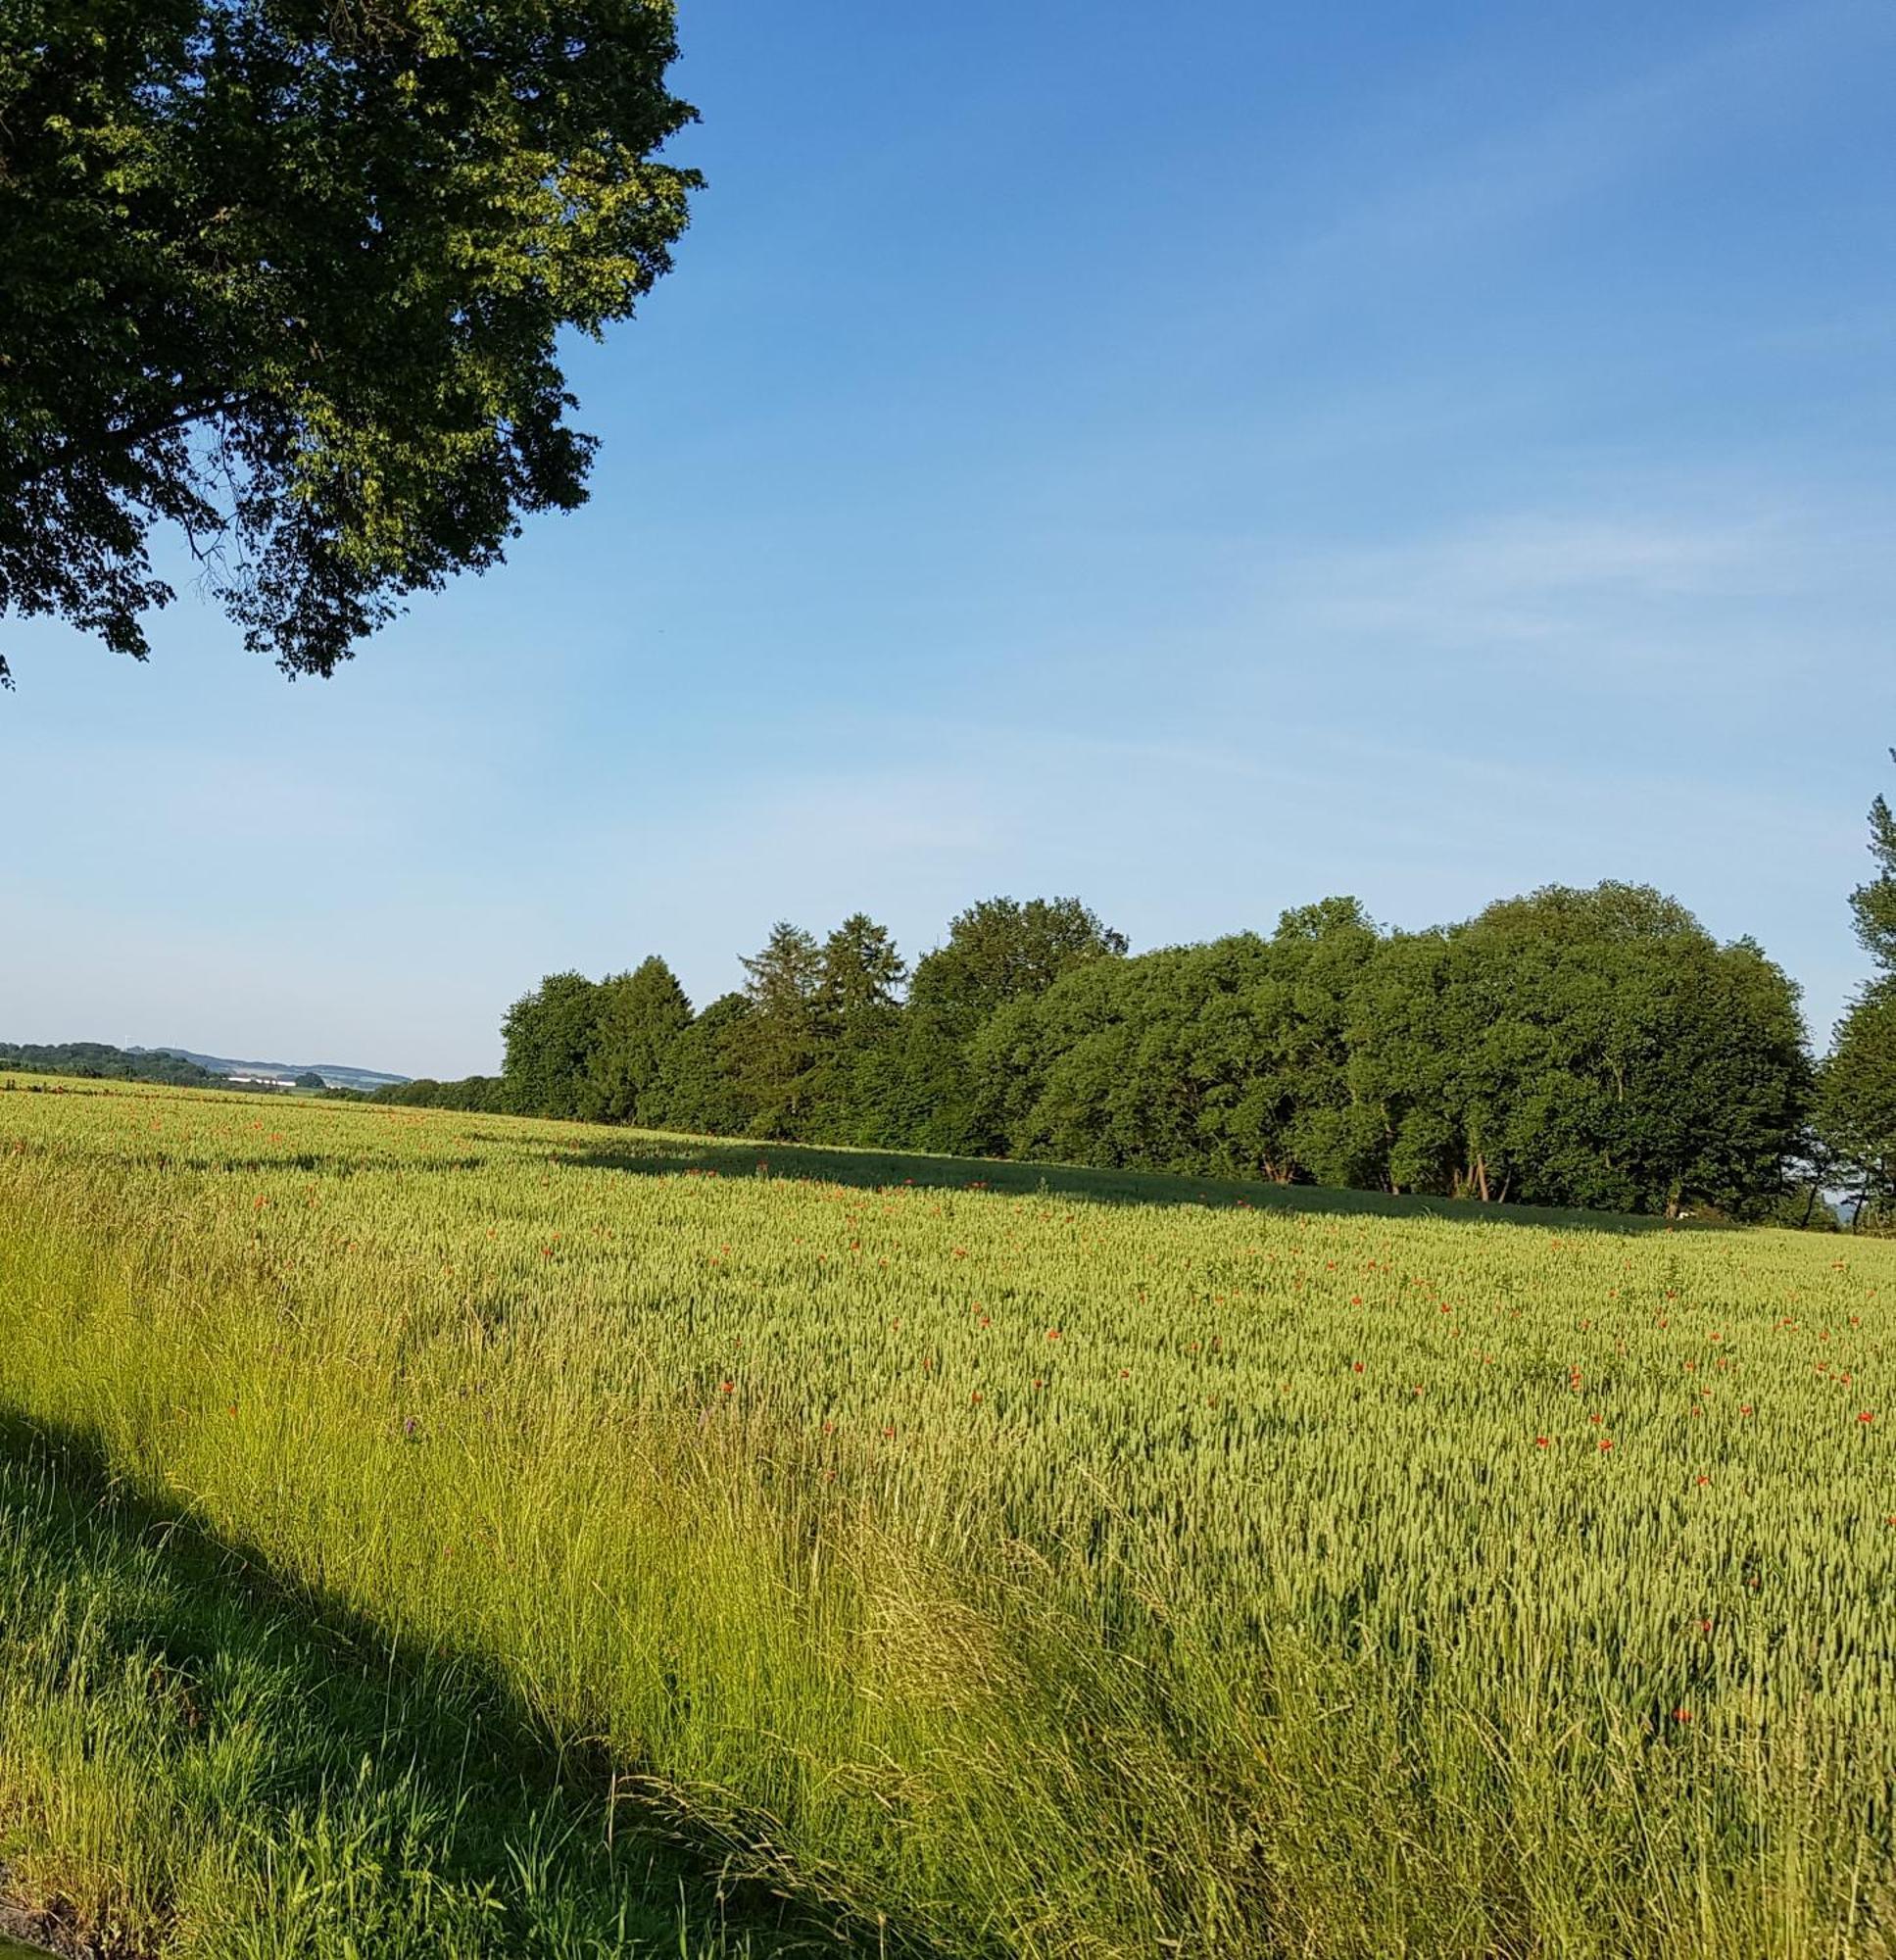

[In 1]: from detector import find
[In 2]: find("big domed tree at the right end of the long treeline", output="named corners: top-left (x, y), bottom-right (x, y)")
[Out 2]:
top-left (1349, 884), bottom-right (1810, 1211)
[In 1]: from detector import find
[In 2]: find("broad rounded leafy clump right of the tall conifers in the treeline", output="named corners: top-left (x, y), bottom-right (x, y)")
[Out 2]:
top-left (955, 886), bottom-right (1810, 1211)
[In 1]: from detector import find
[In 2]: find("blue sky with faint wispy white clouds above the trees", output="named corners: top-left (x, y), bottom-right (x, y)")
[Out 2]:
top-left (0, 0), bottom-right (1896, 1074)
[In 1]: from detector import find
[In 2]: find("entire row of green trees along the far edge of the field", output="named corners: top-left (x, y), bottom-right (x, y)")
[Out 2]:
top-left (376, 884), bottom-right (1816, 1215)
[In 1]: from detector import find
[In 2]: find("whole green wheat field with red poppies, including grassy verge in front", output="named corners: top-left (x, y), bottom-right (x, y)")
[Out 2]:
top-left (0, 1078), bottom-right (1896, 1960)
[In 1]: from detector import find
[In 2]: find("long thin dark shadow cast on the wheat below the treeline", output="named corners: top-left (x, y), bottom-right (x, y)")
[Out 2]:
top-left (552, 1131), bottom-right (1692, 1233)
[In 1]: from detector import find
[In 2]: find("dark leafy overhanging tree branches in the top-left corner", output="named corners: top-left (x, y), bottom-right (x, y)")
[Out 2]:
top-left (0, 0), bottom-right (698, 676)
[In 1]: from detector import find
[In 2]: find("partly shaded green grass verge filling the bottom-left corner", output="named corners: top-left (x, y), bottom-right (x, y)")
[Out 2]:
top-left (0, 1411), bottom-right (799, 1960)
